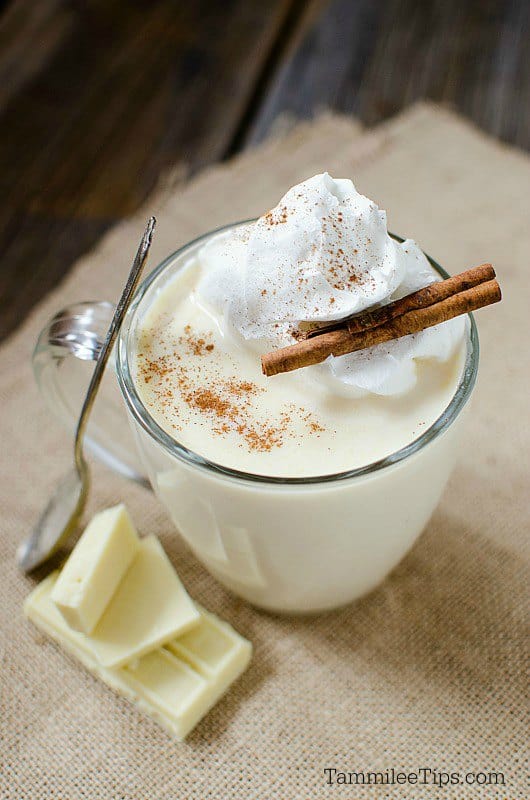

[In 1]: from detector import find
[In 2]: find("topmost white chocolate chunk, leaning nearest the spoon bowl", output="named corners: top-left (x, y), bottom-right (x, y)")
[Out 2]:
top-left (53, 504), bottom-right (140, 633)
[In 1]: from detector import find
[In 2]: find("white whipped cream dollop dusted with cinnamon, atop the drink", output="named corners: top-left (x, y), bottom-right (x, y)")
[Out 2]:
top-left (197, 173), bottom-right (467, 396)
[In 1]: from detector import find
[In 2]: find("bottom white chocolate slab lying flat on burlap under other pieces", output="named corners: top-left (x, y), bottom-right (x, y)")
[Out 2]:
top-left (24, 573), bottom-right (252, 740)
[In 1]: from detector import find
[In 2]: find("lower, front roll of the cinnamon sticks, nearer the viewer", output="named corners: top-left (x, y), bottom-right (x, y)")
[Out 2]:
top-left (261, 273), bottom-right (501, 376)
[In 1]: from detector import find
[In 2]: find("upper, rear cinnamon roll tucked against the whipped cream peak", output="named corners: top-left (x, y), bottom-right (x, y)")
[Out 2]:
top-left (297, 264), bottom-right (495, 341)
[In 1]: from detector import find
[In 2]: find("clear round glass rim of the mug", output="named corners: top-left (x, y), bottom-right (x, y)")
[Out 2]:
top-left (116, 218), bottom-right (479, 486)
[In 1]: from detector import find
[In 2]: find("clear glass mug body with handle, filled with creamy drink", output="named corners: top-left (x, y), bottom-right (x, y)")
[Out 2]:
top-left (34, 221), bottom-right (479, 613)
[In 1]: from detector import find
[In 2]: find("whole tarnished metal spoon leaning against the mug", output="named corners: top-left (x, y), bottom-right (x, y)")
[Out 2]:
top-left (17, 217), bottom-right (156, 572)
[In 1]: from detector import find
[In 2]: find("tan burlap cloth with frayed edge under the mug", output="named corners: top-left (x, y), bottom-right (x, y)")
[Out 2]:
top-left (0, 106), bottom-right (530, 800)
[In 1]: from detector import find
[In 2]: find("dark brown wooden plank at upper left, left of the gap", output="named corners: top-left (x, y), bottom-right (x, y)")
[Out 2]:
top-left (0, 0), bottom-right (291, 336)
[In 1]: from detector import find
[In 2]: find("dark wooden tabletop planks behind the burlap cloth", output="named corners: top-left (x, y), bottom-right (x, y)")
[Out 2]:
top-left (0, 0), bottom-right (530, 337)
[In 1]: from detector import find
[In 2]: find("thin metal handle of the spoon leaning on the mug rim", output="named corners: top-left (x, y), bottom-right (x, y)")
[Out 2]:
top-left (74, 217), bottom-right (156, 470)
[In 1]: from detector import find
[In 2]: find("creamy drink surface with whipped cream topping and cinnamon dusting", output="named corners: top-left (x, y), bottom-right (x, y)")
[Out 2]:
top-left (134, 174), bottom-right (467, 477)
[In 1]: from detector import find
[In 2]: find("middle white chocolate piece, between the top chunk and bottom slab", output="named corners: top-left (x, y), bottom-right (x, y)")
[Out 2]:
top-left (84, 536), bottom-right (200, 667)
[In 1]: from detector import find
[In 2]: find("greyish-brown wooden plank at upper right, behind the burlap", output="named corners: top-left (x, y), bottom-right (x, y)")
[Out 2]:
top-left (245, 0), bottom-right (530, 148)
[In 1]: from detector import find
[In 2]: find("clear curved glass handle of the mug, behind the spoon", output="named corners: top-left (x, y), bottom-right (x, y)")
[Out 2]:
top-left (33, 301), bottom-right (151, 488)
